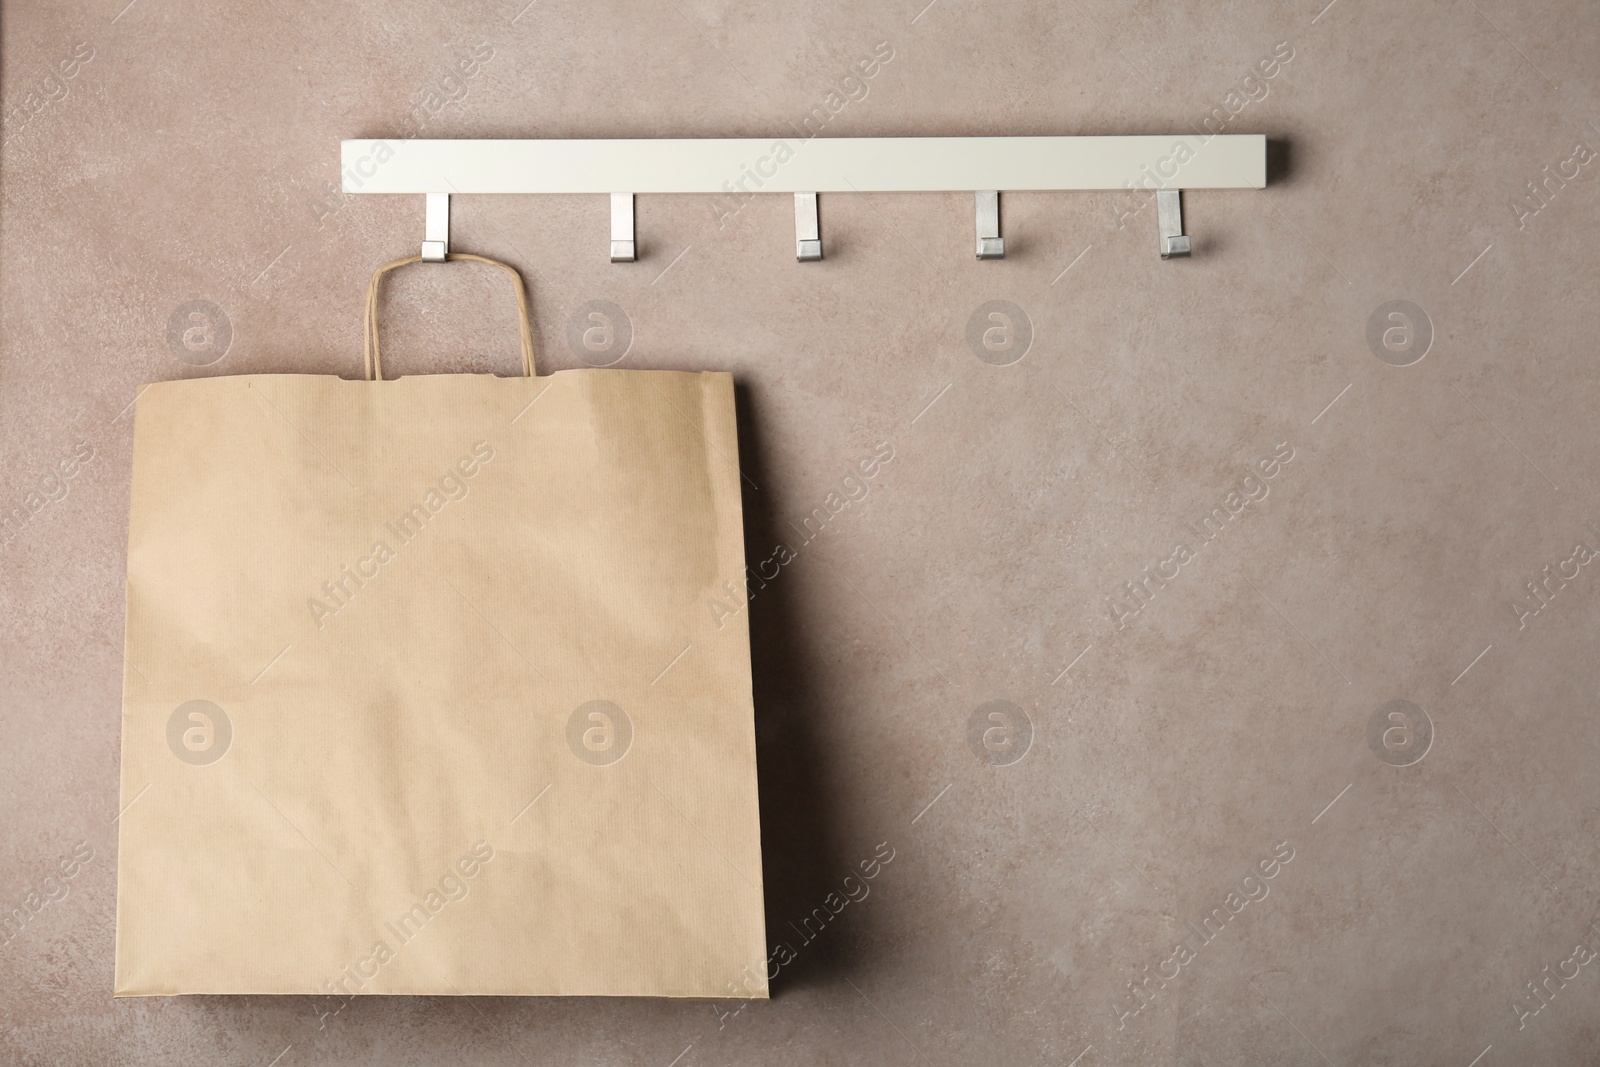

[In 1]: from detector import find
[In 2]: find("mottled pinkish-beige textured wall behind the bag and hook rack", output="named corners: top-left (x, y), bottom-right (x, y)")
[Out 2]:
top-left (0, 0), bottom-right (1600, 1067)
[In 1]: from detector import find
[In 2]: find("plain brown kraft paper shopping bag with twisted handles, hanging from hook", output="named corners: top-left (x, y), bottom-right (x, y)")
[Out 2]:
top-left (115, 256), bottom-right (766, 997)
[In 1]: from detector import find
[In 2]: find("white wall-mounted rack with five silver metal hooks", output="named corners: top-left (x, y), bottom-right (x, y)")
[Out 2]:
top-left (339, 134), bottom-right (1267, 262)
